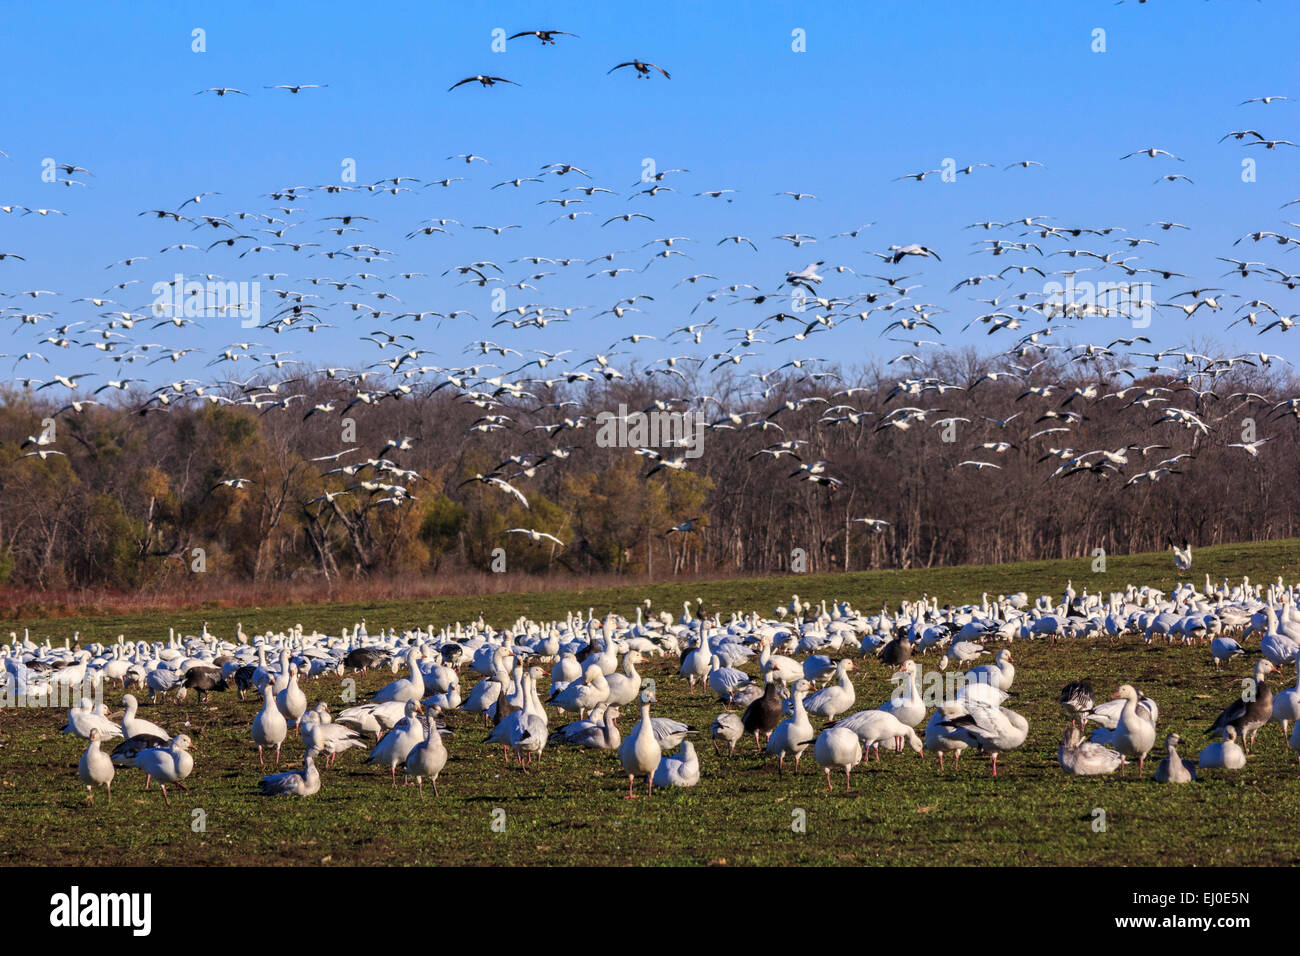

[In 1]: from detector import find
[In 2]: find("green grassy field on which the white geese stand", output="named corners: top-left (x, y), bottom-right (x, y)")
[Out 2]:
top-left (0, 541), bottom-right (1300, 865)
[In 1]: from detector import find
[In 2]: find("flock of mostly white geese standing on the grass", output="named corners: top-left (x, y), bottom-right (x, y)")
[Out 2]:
top-left (10, 567), bottom-right (1300, 804)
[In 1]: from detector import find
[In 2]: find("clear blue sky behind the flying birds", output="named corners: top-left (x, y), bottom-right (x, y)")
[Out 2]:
top-left (0, 0), bottom-right (1300, 390)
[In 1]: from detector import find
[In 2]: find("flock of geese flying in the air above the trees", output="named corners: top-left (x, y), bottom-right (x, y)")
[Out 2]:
top-left (0, 20), bottom-right (1300, 554)
